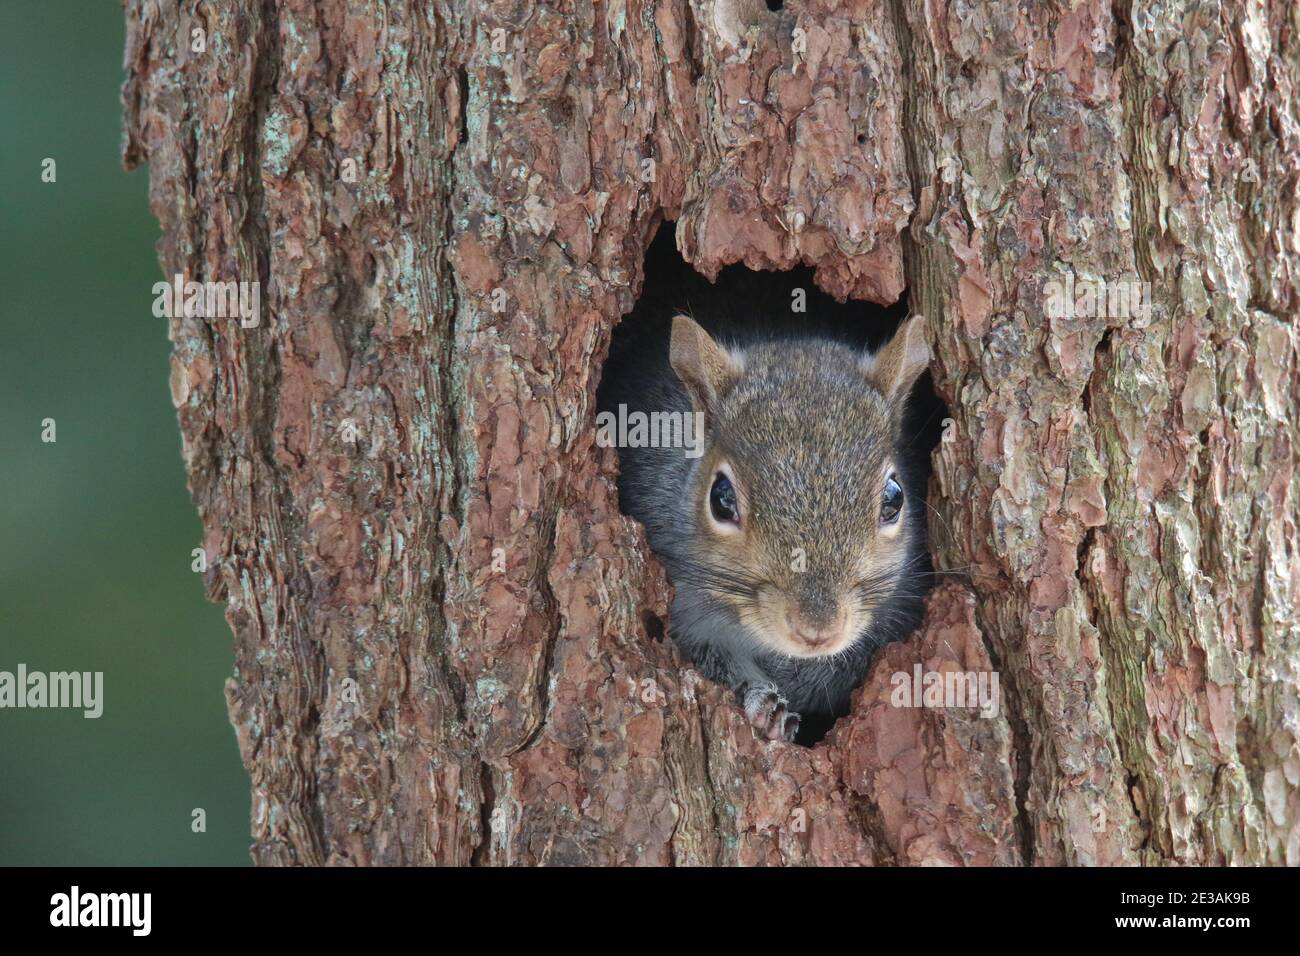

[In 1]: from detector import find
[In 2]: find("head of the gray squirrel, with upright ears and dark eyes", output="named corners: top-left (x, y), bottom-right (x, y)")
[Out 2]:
top-left (670, 316), bottom-right (930, 657)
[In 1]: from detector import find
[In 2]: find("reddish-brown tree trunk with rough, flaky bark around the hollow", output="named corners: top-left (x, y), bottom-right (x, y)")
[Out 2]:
top-left (124, 0), bottom-right (1300, 865)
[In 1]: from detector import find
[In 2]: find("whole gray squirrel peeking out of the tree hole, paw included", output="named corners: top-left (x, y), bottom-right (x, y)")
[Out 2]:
top-left (599, 297), bottom-right (931, 743)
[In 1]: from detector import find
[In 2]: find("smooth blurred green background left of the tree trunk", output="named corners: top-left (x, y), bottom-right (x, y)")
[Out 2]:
top-left (0, 0), bottom-right (250, 865)
